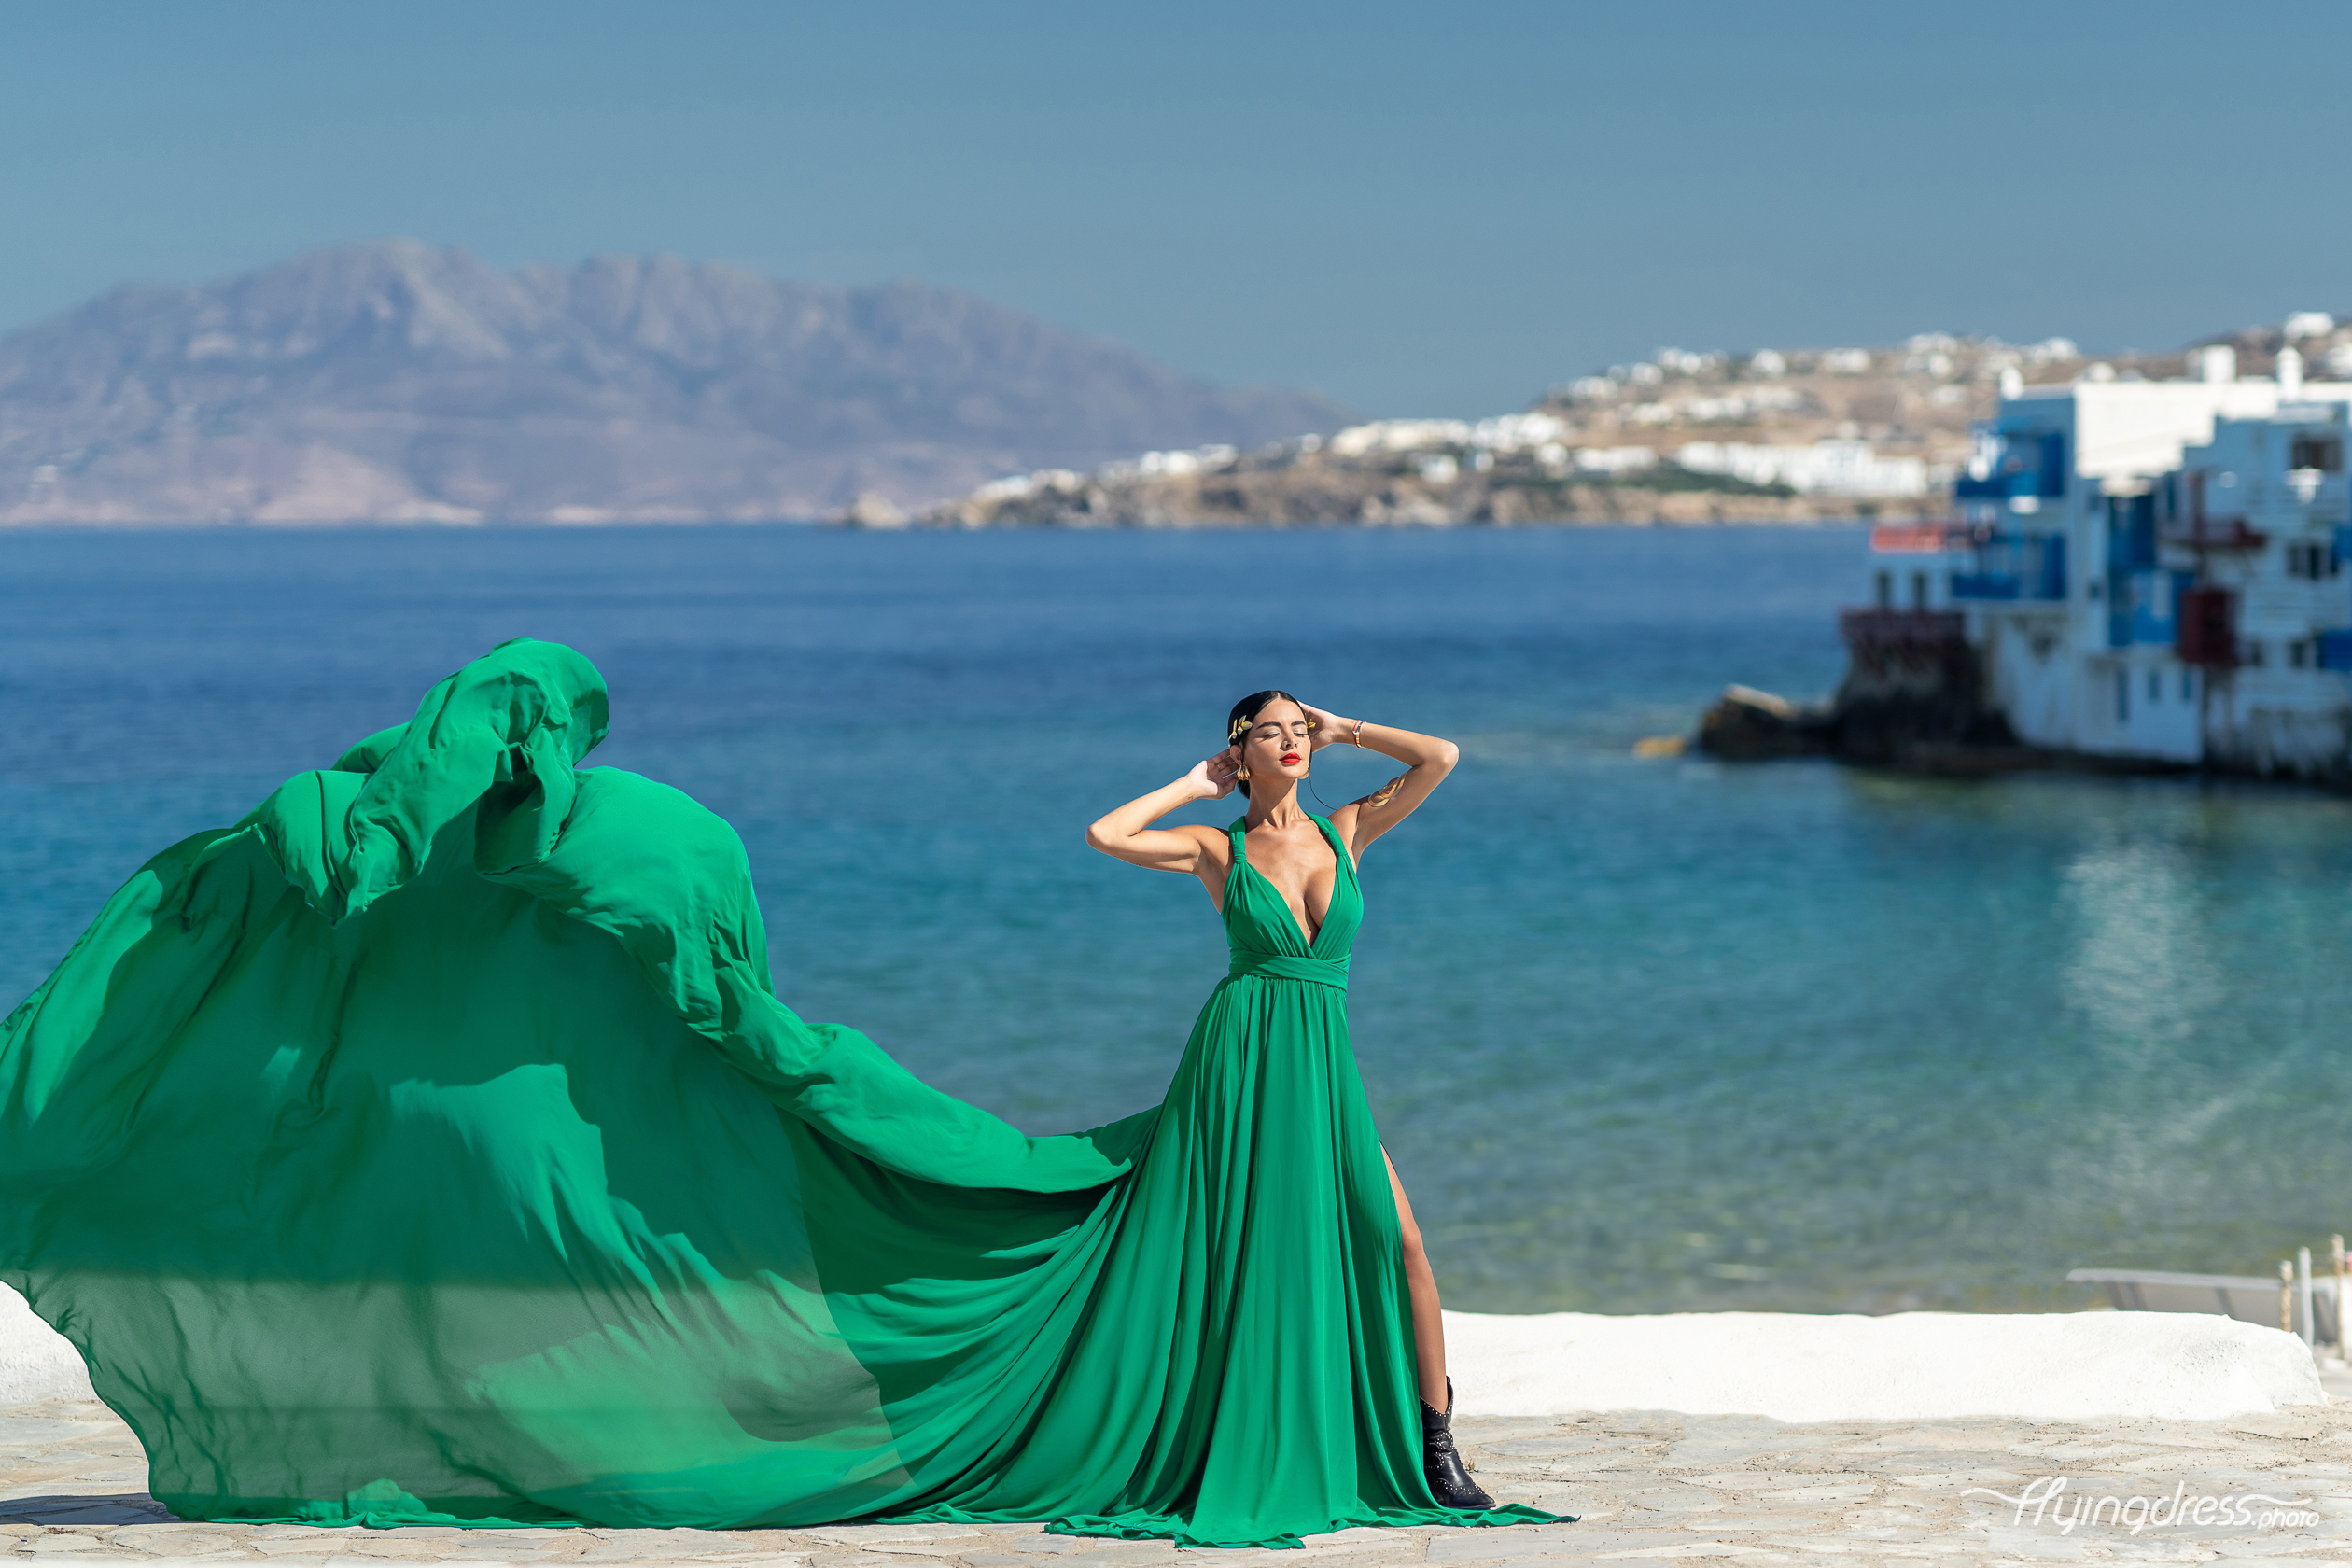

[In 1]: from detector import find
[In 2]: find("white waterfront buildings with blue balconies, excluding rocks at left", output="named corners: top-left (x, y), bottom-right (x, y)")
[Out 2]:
top-left (1855, 350), bottom-right (2352, 774)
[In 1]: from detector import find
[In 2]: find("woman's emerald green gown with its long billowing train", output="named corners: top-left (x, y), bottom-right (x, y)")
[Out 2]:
top-left (0, 639), bottom-right (1550, 1545)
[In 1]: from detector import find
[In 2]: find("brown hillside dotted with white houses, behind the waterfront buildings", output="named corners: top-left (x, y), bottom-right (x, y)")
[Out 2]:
top-left (893, 322), bottom-right (2276, 526)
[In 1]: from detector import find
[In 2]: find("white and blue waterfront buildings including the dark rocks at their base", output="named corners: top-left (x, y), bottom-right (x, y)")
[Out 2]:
top-left (1702, 313), bottom-right (2352, 785)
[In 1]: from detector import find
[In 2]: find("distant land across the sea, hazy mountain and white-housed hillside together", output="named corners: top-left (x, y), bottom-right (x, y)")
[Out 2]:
top-left (0, 240), bottom-right (2323, 529)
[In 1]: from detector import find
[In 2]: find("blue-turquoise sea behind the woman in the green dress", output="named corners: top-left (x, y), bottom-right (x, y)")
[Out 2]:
top-left (0, 526), bottom-right (2352, 1311)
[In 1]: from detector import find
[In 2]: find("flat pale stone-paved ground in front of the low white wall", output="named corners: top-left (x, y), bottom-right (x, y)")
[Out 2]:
top-left (0, 1401), bottom-right (2352, 1568)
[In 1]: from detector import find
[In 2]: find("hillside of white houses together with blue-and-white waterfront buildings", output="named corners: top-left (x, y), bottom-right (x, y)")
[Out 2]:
top-left (903, 310), bottom-right (2352, 783)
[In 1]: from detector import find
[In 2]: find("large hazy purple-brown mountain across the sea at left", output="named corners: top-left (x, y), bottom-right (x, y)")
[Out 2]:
top-left (0, 240), bottom-right (1350, 525)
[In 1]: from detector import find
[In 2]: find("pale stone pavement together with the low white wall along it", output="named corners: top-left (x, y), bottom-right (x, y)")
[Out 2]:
top-left (0, 1288), bottom-right (2352, 1568)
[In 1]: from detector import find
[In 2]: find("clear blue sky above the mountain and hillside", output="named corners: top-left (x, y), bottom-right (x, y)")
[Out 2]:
top-left (0, 0), bottom-right (2352, 413)
